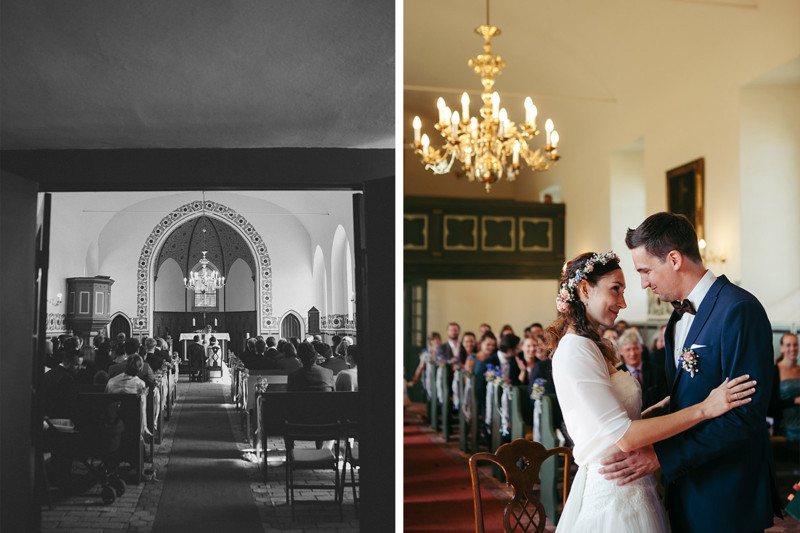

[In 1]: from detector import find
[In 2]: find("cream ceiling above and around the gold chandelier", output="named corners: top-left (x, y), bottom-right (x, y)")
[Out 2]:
top-left (403, 0), bottom-right (800, 133)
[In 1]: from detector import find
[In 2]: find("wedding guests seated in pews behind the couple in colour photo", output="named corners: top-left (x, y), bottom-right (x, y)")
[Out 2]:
top-left (404, 320), bottom-right (800, 531)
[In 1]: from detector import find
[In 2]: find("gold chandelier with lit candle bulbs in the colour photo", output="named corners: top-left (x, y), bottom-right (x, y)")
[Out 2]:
top-left (413, 0), bottom-right (560, 192)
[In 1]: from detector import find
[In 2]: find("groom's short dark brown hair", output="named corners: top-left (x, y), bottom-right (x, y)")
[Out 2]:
top-left (625, 211), bottom-right (703, 264)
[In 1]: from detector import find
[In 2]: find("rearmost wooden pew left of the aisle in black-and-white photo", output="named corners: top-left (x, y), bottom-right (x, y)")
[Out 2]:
top-left (75, 385), bottom-right (144, 484)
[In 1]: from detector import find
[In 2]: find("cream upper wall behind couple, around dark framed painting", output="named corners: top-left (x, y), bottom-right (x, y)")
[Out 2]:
top-left (403, 3), bottom-right (800, 329)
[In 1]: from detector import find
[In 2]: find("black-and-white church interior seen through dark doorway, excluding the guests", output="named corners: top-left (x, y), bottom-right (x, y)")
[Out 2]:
top-left (0, 1), bottom-right (396, 531)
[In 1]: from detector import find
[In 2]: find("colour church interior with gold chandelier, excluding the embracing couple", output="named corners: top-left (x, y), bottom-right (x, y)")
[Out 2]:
top-left (402, 0), bottom-right (800, 531)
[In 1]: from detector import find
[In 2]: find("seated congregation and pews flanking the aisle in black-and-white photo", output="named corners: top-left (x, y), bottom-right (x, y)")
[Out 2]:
top-left (43, 335), bottom-right (359, 520)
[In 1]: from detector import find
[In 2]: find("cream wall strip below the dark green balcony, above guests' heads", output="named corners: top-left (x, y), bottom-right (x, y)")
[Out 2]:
top-left (427, 280), bottom-right (558, 336)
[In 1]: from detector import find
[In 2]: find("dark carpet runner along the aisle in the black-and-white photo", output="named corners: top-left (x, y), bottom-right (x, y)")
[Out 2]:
top-left (153, 383), bottom-right (263, 533)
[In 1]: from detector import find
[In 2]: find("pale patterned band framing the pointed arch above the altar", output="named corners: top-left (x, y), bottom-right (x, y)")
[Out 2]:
top-left (132, 200), bottom-right (278, 334)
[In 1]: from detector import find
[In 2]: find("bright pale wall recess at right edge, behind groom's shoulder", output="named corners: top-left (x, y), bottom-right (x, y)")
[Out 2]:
top-left (740, 80), bottom-right (800, 325)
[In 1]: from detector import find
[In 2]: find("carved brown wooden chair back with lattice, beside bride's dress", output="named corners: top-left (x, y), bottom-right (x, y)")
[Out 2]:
top-left (469, 439), bottom-right (572, 533)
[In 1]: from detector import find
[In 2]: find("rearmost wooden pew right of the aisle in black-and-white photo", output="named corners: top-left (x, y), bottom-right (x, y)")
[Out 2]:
top-left (258, 389), bottom-right (359, 481)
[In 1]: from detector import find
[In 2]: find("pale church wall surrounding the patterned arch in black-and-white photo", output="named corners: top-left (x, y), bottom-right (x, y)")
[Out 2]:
top-left (48, 191), bottom-right (352, 332)
